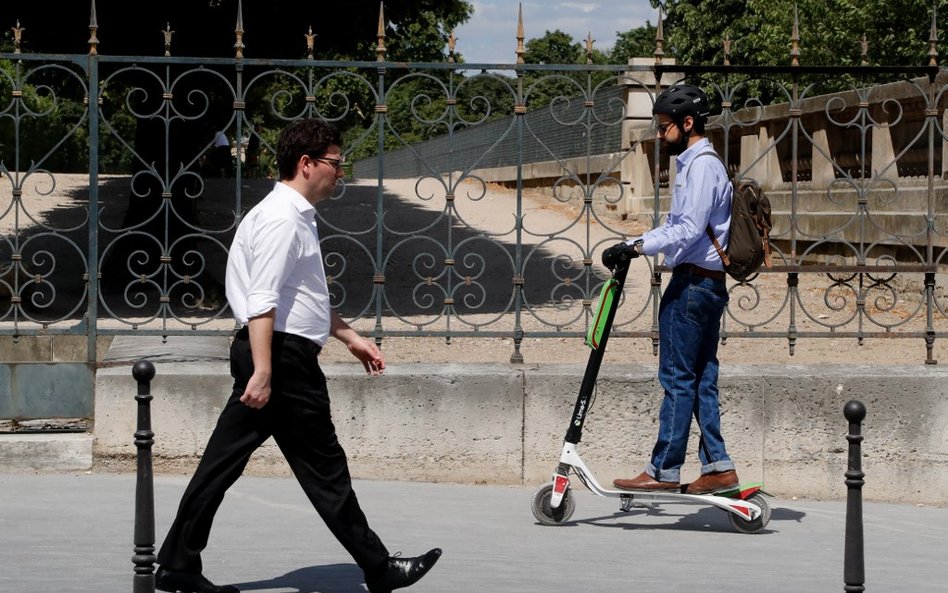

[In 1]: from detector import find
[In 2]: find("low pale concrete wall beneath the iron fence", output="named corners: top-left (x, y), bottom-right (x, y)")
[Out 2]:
top-left (94, 363), bottom-right (948, 504)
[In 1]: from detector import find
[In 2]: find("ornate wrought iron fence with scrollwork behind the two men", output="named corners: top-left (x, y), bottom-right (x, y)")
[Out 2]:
top-left (0, 48), bottom-right (946, 362)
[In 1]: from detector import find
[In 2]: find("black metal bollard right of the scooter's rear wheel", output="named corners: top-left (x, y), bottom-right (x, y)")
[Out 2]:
top-left (843, 400), bottom-right (866, 592)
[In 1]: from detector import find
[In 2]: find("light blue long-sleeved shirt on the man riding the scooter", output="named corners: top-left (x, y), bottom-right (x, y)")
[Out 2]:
top-left (642, 138), bottom-right (731, 270)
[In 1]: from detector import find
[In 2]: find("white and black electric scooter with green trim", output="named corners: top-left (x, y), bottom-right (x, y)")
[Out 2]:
top-left (532, 257), bottom-right (770, 533)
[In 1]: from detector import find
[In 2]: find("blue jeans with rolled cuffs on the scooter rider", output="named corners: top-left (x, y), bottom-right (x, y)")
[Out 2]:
top-left (645, 272), bottom-right (734, 482)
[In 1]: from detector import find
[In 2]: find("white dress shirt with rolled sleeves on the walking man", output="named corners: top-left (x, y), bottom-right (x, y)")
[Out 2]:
top-left (224, 182), bottom-right (332, 346)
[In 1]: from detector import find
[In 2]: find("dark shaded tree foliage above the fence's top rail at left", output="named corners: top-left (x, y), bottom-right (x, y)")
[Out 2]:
top-left (5, 0), bottom-right (473, 62)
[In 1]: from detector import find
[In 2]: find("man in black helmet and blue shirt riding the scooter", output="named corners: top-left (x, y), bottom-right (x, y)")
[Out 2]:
top-left (602, 85), bottom-right (739, 494)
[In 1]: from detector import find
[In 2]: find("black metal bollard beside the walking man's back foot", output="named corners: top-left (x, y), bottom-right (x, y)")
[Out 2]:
top-left (132, 360), bottom-right (155, 593)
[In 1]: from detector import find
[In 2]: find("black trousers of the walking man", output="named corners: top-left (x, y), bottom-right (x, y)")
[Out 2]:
top-left (158, 328), bottom-right (389, 573)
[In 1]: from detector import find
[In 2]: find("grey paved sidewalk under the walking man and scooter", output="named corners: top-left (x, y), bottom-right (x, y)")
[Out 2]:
top-left (0, 473), bottom-right (948, 593)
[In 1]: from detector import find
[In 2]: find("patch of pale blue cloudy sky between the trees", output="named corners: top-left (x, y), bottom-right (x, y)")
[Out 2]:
top-left (454, 0), bottom-right (658, 64)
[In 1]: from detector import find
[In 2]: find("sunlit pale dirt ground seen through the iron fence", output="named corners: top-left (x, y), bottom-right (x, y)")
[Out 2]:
top-left (0, 175), bottom-right (948, 365)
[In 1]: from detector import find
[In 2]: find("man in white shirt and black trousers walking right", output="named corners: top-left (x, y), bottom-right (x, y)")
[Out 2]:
top-left (155, 119), bottom-right (441, 593)
